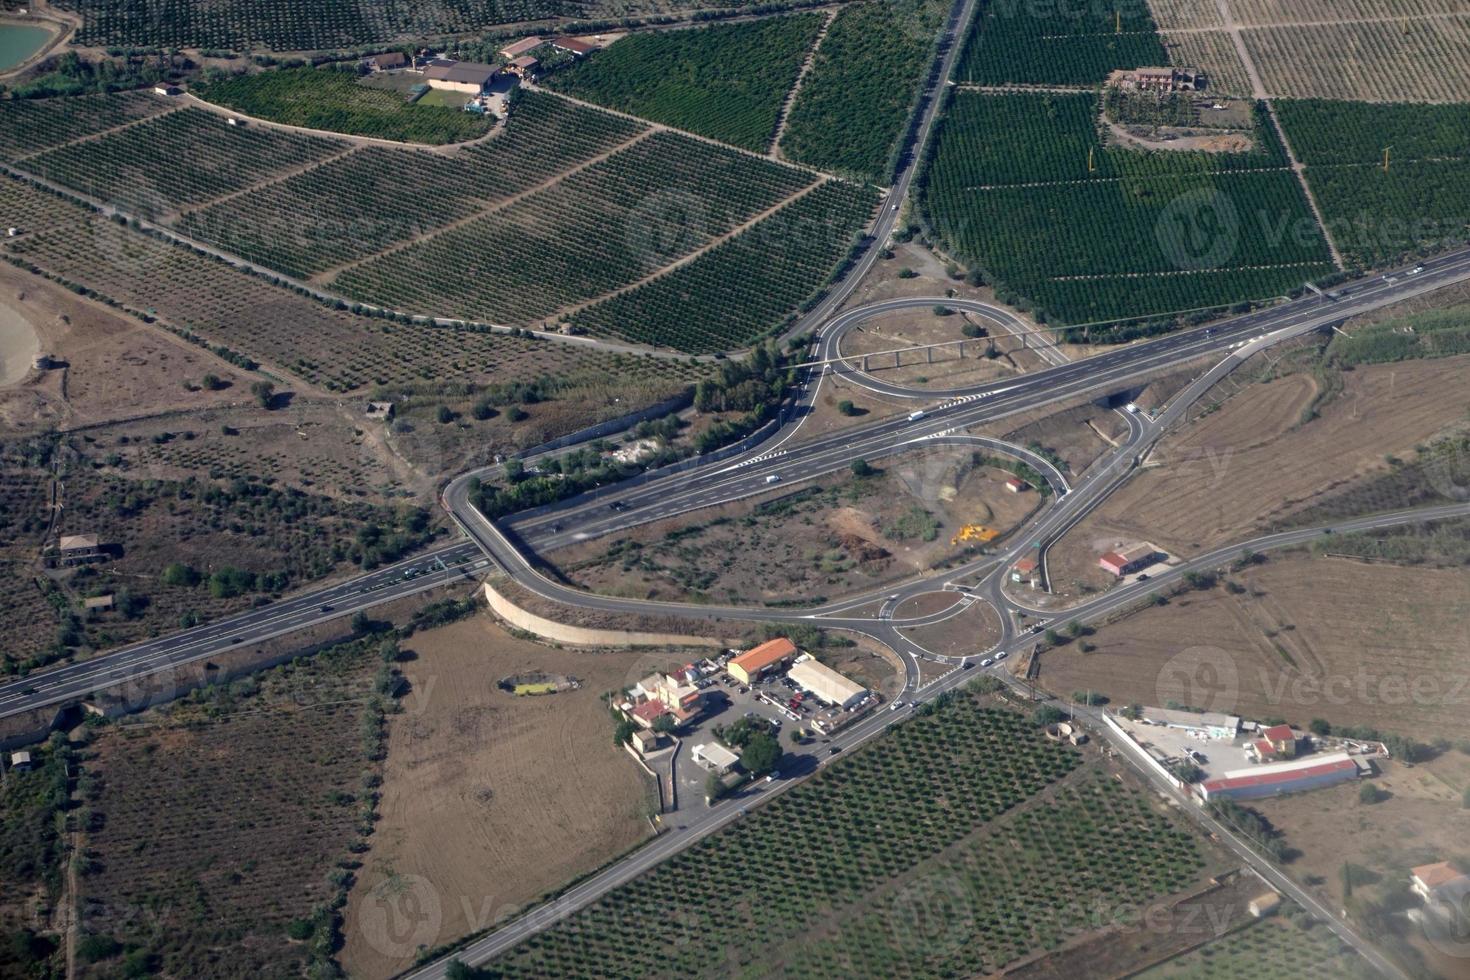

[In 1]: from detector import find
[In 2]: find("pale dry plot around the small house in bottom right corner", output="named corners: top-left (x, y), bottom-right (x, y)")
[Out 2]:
top-left (1252, 749), bottom-right (1470, 977)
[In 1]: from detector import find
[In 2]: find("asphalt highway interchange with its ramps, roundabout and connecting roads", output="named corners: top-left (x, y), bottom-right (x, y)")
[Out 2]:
top-left (0, 0), bottom-right (1470, 979)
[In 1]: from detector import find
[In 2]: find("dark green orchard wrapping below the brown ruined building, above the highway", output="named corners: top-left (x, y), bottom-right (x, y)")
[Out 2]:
top-left (920, 93), bottom-right (1332, 323)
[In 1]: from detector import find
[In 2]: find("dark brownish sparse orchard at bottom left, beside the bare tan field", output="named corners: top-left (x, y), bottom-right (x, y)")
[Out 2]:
top-left (78, 639), bottom-right (390, 979)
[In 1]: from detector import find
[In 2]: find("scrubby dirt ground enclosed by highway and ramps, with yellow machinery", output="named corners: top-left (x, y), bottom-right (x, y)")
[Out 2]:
top-left (554, 448), bottom-right (1039, 602)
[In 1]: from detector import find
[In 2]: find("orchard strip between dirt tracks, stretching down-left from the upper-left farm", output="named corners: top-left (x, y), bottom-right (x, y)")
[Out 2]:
top-left (179, 93), bottom-right (644, 278)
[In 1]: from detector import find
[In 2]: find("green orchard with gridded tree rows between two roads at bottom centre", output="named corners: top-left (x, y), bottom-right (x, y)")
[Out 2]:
top-left (492, 698), bottom-right (1204, 977)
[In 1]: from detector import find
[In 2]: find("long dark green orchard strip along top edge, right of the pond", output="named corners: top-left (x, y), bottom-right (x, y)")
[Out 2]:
top-left (57, 0), bottom-right (723, 51)
